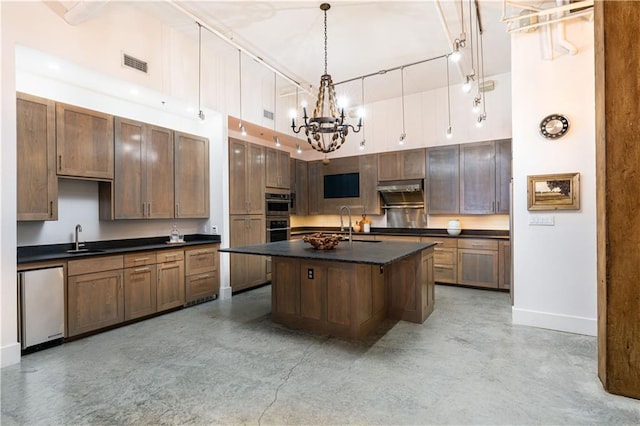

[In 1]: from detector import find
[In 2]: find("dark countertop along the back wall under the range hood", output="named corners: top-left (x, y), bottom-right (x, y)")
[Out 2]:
top-left (291, 226), bottom-right (509, 240)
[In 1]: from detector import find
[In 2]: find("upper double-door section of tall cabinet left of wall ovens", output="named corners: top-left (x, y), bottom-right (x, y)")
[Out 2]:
top-left (229, 138), bottom-right (264, 215)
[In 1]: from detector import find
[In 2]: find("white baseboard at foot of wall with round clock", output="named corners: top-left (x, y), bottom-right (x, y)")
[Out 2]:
top-left (511, 307), bottom-right (598, 336)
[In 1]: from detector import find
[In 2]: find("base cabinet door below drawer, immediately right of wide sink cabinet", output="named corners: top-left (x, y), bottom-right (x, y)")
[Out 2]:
top-left (124, 265), bottom-right (157, 321)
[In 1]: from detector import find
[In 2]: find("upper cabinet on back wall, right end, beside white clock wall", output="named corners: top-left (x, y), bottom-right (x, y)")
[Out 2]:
top-left (460, 139), bottom-right (511, 214)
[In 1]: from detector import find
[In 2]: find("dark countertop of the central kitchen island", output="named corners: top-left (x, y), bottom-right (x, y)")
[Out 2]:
top-left (220, 240), bottom-right (435, 265)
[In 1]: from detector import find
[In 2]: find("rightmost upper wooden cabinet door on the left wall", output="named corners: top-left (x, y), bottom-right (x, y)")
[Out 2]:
top-left (174, 132), bottom-right (209, 218)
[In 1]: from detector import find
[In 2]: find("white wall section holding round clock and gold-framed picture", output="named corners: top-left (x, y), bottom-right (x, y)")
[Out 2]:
top-left (511, 21), bottom-right (597, 335)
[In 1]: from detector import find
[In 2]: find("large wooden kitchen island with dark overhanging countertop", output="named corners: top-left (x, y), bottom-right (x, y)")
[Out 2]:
top-left (220, 240), bottom-right (435, 338)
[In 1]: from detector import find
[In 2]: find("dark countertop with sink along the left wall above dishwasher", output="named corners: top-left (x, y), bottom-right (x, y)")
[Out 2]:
top-left (18, 234), bottom-right (220, 265)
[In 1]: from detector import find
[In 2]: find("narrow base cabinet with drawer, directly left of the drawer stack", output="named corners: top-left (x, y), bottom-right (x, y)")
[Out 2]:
top-left (156, 250), bottom-right (185, 312)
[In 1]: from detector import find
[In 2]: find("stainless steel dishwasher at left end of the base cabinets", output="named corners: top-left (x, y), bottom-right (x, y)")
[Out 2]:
top-left (18, 267), bottom-right (64, 351)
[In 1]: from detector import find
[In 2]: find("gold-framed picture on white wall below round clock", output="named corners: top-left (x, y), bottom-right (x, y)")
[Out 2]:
top-left (527, 173), bottom-right (580, 210)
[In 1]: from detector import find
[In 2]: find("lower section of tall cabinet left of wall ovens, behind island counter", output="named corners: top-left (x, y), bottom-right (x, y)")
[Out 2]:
top-left (229, 215), bottom-right (267, 292)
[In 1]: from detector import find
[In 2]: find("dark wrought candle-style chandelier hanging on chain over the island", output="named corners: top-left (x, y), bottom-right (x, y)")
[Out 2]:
top-left (291, 3), bottom-right (362, 154)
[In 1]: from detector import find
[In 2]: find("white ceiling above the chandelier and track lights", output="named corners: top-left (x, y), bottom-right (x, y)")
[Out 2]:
top-left (135, 0), bottom-right (510, 102)
